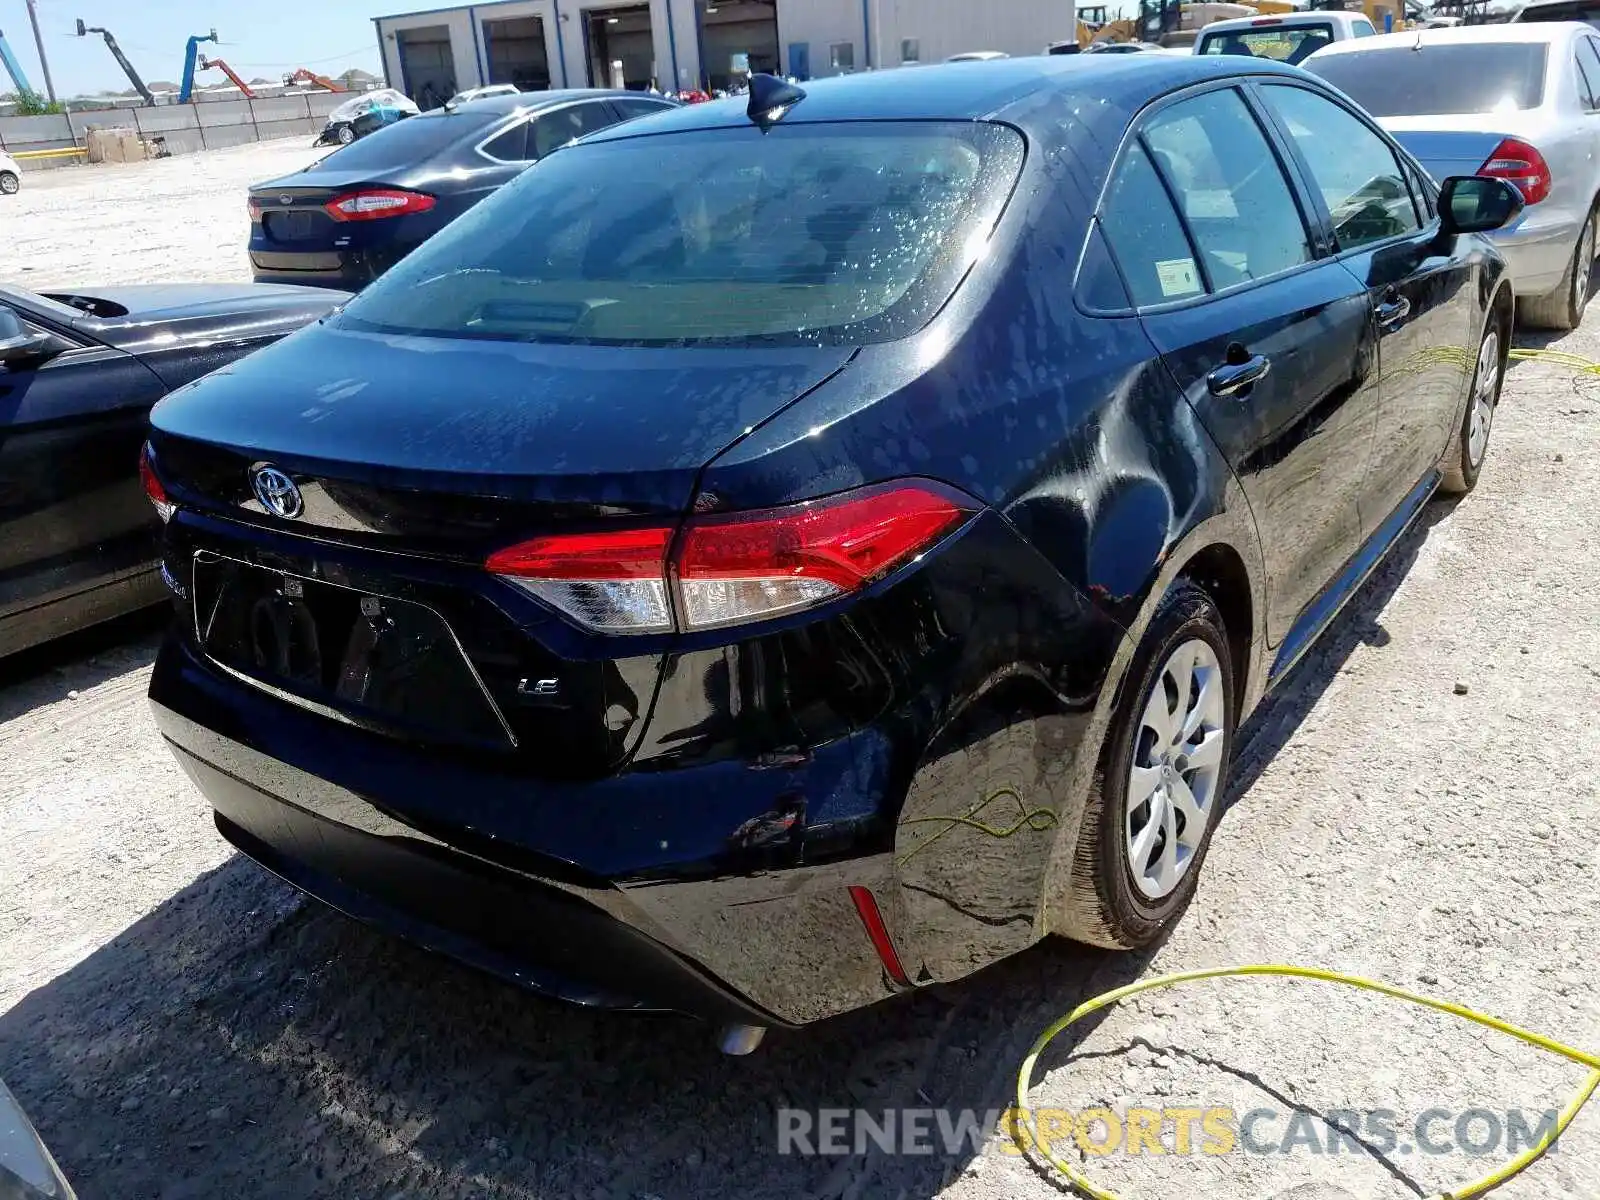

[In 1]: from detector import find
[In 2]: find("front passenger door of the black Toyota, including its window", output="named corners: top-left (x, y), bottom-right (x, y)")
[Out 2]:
top-left (1259, 82), bottom-right (1478, 534)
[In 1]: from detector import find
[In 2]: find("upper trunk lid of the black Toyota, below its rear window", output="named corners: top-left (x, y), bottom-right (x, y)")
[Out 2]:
top-left (150, 325), bottom-right (853, 533)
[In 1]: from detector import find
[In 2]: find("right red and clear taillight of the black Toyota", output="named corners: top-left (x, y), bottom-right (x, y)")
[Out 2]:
top-left (486, 483), bottom-right (973, 634)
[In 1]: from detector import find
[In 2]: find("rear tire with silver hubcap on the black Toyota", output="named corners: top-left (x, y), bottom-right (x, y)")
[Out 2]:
top-left (1054, 579), bottom-right (1235, 950)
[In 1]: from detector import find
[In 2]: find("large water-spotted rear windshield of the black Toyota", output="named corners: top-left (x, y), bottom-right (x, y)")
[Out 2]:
top-left (338, 122), bottom-right (1022, 346)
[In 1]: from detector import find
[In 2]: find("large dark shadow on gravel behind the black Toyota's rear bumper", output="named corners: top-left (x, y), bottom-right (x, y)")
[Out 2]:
top-left (0, 858), bottom-right (1147, 1200)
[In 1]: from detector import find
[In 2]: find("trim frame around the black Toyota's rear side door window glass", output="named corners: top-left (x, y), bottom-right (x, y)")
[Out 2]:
top-left (1072, 75), bottom-right (1333, 317)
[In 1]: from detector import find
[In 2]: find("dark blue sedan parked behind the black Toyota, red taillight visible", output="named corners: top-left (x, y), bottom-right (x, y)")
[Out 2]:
top-left (250, 91), bottom-right (674, 290)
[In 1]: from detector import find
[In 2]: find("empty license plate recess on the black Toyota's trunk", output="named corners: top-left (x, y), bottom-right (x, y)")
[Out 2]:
top-left (194, 550), bottom-right (517, 749)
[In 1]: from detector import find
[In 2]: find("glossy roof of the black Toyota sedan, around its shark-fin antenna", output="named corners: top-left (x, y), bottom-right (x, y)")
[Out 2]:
top-left (584, 54), bottom-right (1306, 144)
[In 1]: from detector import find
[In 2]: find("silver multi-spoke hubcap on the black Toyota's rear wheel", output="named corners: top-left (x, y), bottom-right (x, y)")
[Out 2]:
top-left (1125, 638), bottom-right (1227, 901)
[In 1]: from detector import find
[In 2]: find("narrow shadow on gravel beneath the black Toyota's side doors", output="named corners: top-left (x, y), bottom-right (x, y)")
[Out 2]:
top-left (1227, 499), bottom-right (1458, 808)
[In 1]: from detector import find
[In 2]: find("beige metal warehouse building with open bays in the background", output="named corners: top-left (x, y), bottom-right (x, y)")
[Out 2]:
top-left (373, 0), bottom-right (1077, 106)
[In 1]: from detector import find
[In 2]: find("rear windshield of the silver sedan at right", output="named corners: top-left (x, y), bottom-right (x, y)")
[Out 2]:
top-left (1306, 42), bottom-right (1546, 117)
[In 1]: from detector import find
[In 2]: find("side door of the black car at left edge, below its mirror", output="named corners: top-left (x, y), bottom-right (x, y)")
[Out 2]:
top-left (0, 299), bottom-right (165, 654)
